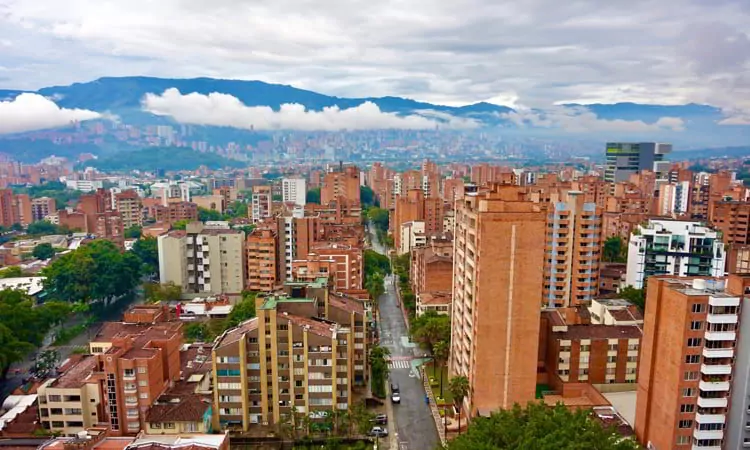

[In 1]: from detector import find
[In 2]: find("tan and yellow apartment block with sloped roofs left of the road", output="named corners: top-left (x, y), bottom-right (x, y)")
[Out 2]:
top-left (213, 296), bottom-right (356, 431)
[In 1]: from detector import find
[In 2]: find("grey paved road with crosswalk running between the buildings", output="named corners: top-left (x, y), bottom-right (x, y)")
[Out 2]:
top-left (371, 224), bottom-right (440, 450)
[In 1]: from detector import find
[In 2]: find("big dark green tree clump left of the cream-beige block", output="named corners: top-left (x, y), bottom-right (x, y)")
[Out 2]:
top-left (42, 239), bottom-right (142, 303)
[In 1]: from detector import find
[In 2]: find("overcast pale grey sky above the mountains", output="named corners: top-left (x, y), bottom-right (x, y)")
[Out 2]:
top-left (0, 0), bottom-right (750, 119)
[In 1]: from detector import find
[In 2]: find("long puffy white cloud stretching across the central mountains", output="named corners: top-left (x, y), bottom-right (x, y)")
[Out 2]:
top-left (142, 88), bottom-right (478, 131)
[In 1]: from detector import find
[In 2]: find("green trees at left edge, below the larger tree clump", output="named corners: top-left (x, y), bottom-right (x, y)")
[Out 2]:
top-left (0, 289), bottom-right (74, 376)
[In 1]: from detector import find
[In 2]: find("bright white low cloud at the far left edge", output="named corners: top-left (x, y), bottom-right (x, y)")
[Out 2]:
top-left (0, 93), bottom-right (102, 134)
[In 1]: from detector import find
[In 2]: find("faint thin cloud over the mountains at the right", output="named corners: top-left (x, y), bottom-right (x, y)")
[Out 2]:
top-left (501, 106), bottom-right (685, 133)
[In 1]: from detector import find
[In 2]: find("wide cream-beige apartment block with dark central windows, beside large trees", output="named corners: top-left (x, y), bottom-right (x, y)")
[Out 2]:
top-left (158, 222), bottom-right (245, 296)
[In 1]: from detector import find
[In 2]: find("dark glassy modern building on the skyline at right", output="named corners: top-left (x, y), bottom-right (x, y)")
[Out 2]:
top-left (604, 142), bottom-right (672, 183)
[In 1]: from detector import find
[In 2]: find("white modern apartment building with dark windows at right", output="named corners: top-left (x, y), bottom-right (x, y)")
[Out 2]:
top-left (625, 220), bottom-right (726, 289)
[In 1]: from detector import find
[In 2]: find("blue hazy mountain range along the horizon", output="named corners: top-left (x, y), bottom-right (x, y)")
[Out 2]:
top-left (0, 77), bottom-right (750, 148)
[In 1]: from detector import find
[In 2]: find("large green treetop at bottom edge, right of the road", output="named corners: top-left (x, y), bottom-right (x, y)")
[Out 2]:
top-left (448, 402), bottom-right (641, 450)
